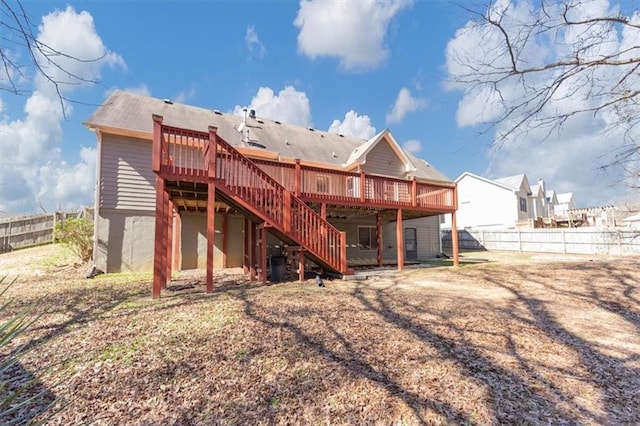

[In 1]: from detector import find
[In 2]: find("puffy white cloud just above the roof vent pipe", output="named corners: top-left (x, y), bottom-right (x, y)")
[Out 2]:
top-left (233, 86), bottom-right (312, 127)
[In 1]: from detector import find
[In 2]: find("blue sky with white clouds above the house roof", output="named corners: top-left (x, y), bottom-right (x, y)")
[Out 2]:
top-left (0, 0), bottom-right (627, 216)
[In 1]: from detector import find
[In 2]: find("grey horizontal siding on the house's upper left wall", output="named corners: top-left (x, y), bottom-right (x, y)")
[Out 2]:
top-left (100, 134), bottom-right (156, 211)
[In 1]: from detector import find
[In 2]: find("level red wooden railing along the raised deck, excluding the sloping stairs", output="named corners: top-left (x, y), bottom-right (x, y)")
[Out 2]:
top-left (154, 116), bottom-right (456, 212)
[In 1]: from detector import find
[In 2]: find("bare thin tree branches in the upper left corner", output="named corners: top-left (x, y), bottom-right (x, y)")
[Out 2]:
top-left (0, 0), bottom-right (104, 113)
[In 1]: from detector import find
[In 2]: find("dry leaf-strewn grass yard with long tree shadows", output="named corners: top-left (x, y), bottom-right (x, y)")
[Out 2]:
top-left (0, 247), bottom-right (640, 425)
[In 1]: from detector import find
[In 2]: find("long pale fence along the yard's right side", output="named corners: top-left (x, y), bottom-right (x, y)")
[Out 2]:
top-left (441, 228), bottom-right (640, 255)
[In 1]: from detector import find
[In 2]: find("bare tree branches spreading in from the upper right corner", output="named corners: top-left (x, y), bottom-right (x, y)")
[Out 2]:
top-left (449, 0), bottom-right (640, 185)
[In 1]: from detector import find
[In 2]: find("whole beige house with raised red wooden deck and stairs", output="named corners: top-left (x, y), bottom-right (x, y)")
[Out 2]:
top-left (85, 91), bottom-right (457, 297)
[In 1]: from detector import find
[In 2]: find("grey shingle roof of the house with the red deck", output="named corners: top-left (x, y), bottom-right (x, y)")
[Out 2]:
top-left (85, 90), bottom-right (451, 182)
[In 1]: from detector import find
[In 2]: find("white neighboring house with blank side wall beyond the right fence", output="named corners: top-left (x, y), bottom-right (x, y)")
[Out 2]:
top-left (442, 172), bottom-right (534, 229)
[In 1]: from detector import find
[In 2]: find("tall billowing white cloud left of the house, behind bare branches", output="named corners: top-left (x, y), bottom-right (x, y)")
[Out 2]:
top-left (0, 6), bottom-right (125, 214)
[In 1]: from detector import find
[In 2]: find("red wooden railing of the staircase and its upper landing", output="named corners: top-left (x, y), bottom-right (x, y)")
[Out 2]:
top-left (154, 119), bottom-right (347, 273)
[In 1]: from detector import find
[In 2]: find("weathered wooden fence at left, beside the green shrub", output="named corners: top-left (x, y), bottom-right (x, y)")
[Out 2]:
top-left (0, 209), bottom-right (88, 253)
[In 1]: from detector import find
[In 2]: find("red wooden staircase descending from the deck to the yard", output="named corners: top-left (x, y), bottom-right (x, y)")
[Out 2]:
top-left (159, 121), bottom-right (353, 275)
